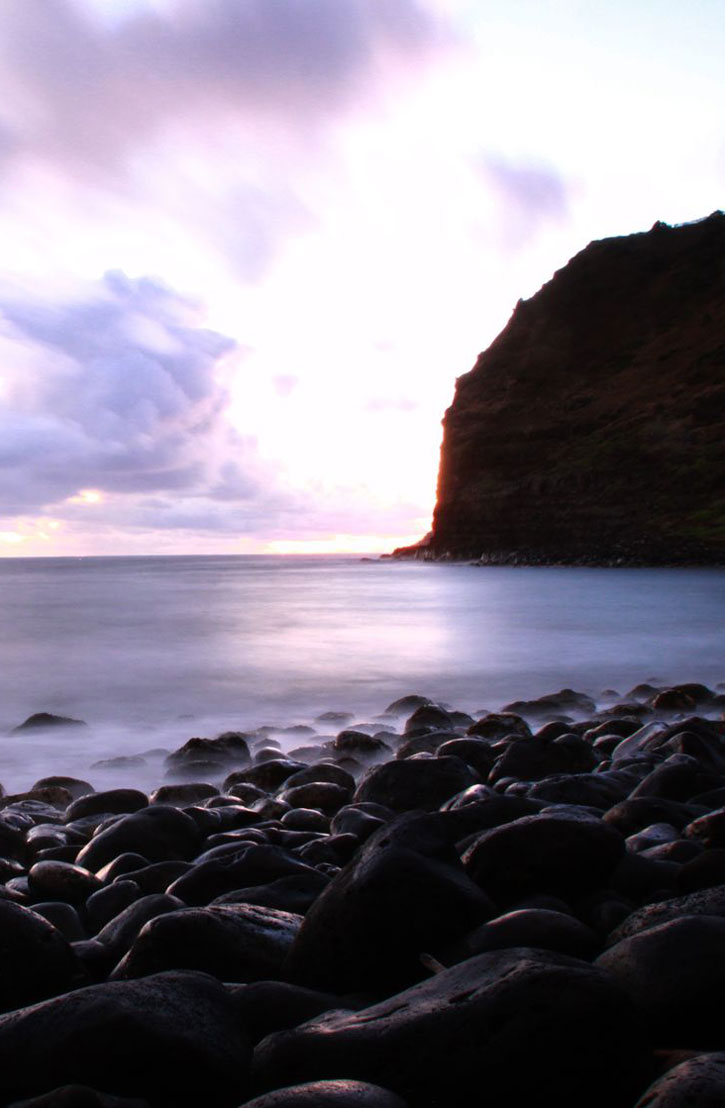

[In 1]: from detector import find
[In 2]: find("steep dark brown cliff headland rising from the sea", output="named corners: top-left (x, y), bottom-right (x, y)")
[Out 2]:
top-left (403, 213), bottom-right (725, 564)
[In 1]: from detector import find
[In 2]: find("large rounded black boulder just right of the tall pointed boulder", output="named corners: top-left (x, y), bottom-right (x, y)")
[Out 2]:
top-left (462, 813), bottom-right (624, 905)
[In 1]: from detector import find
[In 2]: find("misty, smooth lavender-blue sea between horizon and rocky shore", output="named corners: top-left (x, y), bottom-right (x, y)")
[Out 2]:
top-left (0, 556), bottom-right (725, 789)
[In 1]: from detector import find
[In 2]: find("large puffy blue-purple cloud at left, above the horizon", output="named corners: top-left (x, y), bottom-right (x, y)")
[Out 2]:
top-left (0, 273), bottom-right (256, 515)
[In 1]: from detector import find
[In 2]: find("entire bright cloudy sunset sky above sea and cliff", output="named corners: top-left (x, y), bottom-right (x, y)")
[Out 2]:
top-left (0, 0), bottom-right (725, 557)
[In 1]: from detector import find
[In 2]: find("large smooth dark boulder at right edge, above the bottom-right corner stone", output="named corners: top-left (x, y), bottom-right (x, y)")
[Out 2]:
top-left (596, 915), bottom-right (725, 1049)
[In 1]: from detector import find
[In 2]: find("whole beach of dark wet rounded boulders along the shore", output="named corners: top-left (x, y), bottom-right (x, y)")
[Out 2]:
top-left (0, 685), bottom-right (725, 1108)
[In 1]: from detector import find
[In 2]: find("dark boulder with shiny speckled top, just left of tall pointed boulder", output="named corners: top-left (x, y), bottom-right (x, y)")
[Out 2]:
top-left (111, 904), bottom-right (302, 982)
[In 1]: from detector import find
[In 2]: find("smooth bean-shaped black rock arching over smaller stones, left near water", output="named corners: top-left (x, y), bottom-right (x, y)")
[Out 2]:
top-left (75, 793), bottom-right (200, 872)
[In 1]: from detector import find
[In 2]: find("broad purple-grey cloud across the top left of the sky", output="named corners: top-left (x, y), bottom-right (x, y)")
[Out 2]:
top-left (0, 0), bottom-right (446, 172)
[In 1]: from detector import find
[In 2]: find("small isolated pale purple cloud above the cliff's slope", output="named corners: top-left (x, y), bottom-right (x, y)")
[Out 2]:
top-left (478, 154), bottom-right (570, 246)
